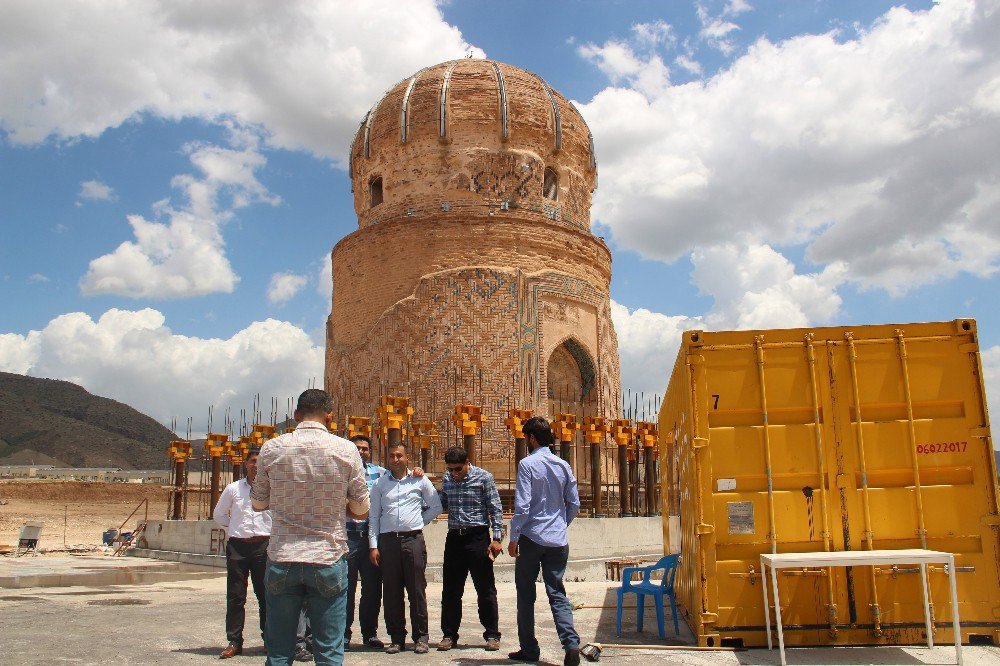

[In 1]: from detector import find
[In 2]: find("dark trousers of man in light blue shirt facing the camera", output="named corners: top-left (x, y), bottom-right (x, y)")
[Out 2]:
top-left (378, 532), bottom-right (429, 644)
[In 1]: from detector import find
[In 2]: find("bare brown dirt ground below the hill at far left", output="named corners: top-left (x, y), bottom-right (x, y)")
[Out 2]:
top-left (0, 479), bottom-right (167, 552)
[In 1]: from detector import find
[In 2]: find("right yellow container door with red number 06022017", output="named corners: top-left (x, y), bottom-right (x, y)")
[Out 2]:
top-left (828, 323), bottom-right (1000, 643)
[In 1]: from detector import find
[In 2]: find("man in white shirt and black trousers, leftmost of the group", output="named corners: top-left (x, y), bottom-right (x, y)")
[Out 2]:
top-left (212, 449), bottom-right (271, 659)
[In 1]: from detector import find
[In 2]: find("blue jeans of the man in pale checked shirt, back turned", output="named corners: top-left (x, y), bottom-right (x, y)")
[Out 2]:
top-left (264, 559), bottom-right (347, 666)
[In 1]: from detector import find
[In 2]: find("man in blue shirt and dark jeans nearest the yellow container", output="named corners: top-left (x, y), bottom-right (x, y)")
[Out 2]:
top-left (508, 416), bottom-right (580, 666)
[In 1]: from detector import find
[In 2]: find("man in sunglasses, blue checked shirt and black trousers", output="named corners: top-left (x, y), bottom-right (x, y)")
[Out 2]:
top-left (437, 446), bottom-right (503, 651)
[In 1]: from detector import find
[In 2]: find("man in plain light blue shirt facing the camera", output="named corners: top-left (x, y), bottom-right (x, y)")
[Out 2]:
top-left (368, 444), bottom-right (441, 654)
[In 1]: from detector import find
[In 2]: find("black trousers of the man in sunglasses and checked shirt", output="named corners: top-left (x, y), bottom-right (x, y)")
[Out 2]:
top-left (441, 525), bottom-right (500, 642)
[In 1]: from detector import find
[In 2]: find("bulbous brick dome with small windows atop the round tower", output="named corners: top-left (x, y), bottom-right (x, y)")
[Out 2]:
top-left (350, 59), bottom-right (597, 230)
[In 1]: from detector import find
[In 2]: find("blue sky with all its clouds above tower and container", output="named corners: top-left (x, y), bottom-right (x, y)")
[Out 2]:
top-left (0, 0), bottom-right (1000, 430)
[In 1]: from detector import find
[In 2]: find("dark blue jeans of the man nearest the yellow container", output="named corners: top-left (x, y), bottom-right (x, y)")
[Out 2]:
top-left (516, 535), bottom-right (580, 659)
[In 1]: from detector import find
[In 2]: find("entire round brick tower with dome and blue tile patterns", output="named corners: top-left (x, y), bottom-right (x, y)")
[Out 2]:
top-left (326, 59), bottom-right (621, 467)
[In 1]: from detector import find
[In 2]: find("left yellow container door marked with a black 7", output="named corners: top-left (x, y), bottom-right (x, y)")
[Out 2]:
top-left (696, 339), bottom-right (839, 644)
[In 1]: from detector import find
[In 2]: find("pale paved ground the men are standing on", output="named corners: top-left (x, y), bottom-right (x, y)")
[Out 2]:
top-left (0, 555), bottom-right (1000, 666)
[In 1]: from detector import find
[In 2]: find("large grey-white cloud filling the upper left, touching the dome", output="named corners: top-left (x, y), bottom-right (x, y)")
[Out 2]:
top-left (0, 0), bottom-right (482, 164)
